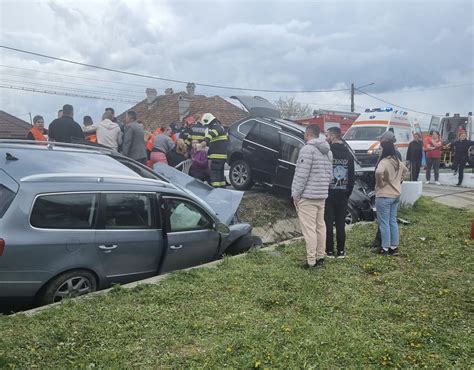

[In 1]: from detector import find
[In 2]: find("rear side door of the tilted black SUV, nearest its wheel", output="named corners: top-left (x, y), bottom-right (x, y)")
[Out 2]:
top-left (242, 121), bottom-right (280, 184)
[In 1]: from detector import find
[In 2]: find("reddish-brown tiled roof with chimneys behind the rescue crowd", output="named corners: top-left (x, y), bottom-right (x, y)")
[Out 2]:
top-left (117, 83), bottom-right (248, 131)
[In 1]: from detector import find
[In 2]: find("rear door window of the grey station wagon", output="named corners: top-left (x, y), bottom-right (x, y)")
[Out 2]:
top-left (105, 193), bottom-right (156, 229)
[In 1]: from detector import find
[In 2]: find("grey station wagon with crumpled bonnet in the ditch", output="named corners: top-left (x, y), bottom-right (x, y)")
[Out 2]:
top-left (0, 140), bottom-right (255, 304)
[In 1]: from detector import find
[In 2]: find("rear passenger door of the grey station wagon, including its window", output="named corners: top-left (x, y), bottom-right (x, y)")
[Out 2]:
top-left (95, 192), bottom-right (163, 284)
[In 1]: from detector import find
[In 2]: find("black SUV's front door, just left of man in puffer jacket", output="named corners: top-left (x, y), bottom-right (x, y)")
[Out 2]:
top-left (274, 132), bottom-right (304, 189)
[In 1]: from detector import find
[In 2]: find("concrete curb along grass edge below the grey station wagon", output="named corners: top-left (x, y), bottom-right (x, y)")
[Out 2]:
top-left (17, 237), bottom-right (303, 316)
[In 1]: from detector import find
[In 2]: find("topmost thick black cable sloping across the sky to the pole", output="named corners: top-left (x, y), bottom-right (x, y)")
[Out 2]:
top-left (0, 45), bottom-right (350, 93)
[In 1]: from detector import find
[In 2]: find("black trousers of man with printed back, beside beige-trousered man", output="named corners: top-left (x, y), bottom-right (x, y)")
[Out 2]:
top-left (324, 193), bottom-right (349, 253)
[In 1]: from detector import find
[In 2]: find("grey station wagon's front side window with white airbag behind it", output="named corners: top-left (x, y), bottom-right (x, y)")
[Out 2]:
top-left (165, 199), bottom-right (214, 232)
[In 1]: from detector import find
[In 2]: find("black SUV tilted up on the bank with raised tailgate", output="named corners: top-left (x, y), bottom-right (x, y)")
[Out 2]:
top-left (228, 96), bottom-right (375, 224)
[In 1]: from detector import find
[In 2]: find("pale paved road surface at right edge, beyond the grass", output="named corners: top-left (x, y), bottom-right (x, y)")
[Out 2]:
top-left (423, 184), bottom-right (474, 209)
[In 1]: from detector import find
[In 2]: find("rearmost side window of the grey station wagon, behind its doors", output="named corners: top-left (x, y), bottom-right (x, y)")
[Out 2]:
top-left (30, 193), bottom-right (98, 229)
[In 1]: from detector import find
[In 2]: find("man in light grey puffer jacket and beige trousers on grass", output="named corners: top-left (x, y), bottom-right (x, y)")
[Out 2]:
top-left (291, 125), bottom-right (332, 268)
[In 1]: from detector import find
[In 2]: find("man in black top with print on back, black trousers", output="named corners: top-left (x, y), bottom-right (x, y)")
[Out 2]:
top-left (324, 127), bottom-right (355, 258)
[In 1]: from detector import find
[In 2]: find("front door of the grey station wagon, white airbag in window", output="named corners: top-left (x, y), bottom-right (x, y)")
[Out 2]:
top-left (160, 197), bottom-right (221, 273)
